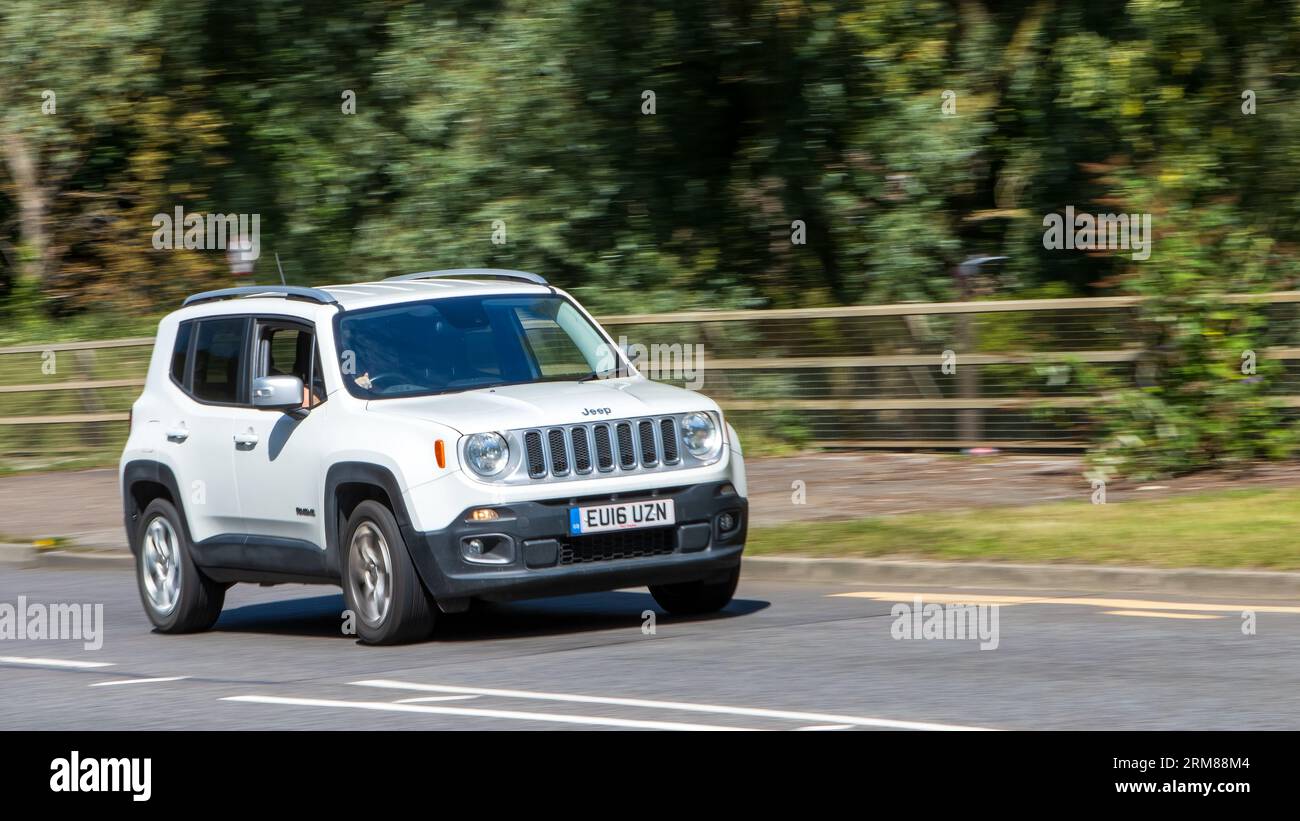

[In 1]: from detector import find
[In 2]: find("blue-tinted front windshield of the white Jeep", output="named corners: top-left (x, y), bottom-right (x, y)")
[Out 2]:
top-left (337, 294), bottom-right (616, 399)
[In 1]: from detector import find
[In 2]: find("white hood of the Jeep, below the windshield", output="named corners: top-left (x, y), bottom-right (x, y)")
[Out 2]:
top-left (367, 379), bottom-right (718, 434)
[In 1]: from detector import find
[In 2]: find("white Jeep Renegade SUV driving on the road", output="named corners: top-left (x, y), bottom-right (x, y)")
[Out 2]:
top-left (120, 270), bottom-right (749, 643)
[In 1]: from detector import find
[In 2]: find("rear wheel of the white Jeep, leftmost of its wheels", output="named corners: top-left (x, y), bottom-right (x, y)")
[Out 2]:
top-left (135, 499), bottom-right (226, 633)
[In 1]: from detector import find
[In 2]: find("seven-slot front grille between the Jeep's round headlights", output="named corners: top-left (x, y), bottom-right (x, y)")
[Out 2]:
top-left (524, 417), bottom-right (681, 479)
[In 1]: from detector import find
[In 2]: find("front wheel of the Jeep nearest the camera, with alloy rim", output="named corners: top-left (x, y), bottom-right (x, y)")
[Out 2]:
top-left (342, 500), bottom-right (437, 644)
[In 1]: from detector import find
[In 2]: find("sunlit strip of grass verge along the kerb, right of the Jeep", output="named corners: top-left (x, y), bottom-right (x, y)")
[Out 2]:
top-left (746, 488), bottom-right (1300, 570)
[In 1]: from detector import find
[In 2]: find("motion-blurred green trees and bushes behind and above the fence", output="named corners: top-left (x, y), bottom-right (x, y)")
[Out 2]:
top-left (0, 0), bottom-right (1300, 469)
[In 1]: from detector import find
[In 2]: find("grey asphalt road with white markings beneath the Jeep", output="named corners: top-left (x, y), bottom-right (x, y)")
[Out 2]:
top-left (0, 568), bottom-right (1300, 731)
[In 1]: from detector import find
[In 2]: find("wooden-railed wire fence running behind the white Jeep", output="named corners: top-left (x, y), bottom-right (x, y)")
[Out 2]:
top-left (0, 292), bottom-right (1300, 466)
